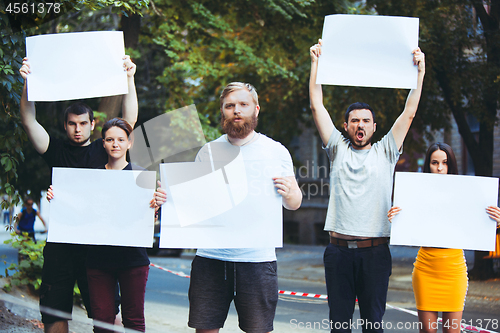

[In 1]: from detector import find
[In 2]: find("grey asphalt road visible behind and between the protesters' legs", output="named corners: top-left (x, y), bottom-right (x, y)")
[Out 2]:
top-left (0, 228), bottom-right (500, 333)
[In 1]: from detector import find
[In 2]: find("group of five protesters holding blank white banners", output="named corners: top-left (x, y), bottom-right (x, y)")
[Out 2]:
top-left (16, 36), bottom-right (500, 333)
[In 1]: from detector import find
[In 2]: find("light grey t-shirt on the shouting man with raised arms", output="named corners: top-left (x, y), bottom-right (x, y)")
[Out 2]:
top-left (324, 129), bottom-right (402, 237)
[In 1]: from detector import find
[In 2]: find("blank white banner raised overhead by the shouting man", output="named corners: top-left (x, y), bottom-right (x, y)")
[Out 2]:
top-left (316, 15), bottom-right (419, 88)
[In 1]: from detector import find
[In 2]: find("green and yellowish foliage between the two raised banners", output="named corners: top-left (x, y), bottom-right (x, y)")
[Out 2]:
top-left (134, 0), bottom-right (344, 145)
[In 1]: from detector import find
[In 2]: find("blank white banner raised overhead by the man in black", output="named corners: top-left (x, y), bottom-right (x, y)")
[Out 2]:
top-left (26, 31), bottom-right (128, 101)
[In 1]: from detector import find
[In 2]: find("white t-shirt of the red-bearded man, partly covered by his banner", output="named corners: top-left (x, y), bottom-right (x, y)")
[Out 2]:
top-left (196, 133), bottom-right (294, 262)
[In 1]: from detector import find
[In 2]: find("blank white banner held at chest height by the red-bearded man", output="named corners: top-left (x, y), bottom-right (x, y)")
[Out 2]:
top-left (160, 160), bottom-right (283, 248)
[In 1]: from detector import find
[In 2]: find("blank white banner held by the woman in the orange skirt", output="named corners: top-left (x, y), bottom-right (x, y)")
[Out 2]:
top-left (391, 172), bottom-right (498, 251)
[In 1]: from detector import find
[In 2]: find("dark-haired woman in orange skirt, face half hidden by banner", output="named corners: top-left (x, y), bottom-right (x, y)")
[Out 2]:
top-left (387, 142), bottom-right (500, 333)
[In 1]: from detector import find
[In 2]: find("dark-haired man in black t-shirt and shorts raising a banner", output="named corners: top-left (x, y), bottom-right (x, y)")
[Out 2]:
top-left (19, 56), bottom-right (138, 333)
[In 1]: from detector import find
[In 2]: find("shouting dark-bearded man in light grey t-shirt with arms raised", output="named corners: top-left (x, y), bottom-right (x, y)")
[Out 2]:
top-left (309, 40), bottom-right (425, 332)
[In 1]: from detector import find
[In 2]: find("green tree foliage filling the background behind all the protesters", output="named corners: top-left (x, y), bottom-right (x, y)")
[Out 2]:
top-left (4, 0), bottom-right (480, 200)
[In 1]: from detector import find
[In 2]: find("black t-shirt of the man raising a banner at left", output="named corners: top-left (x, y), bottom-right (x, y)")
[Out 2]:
top-left (42, 137), bottom-right (108, 169)
